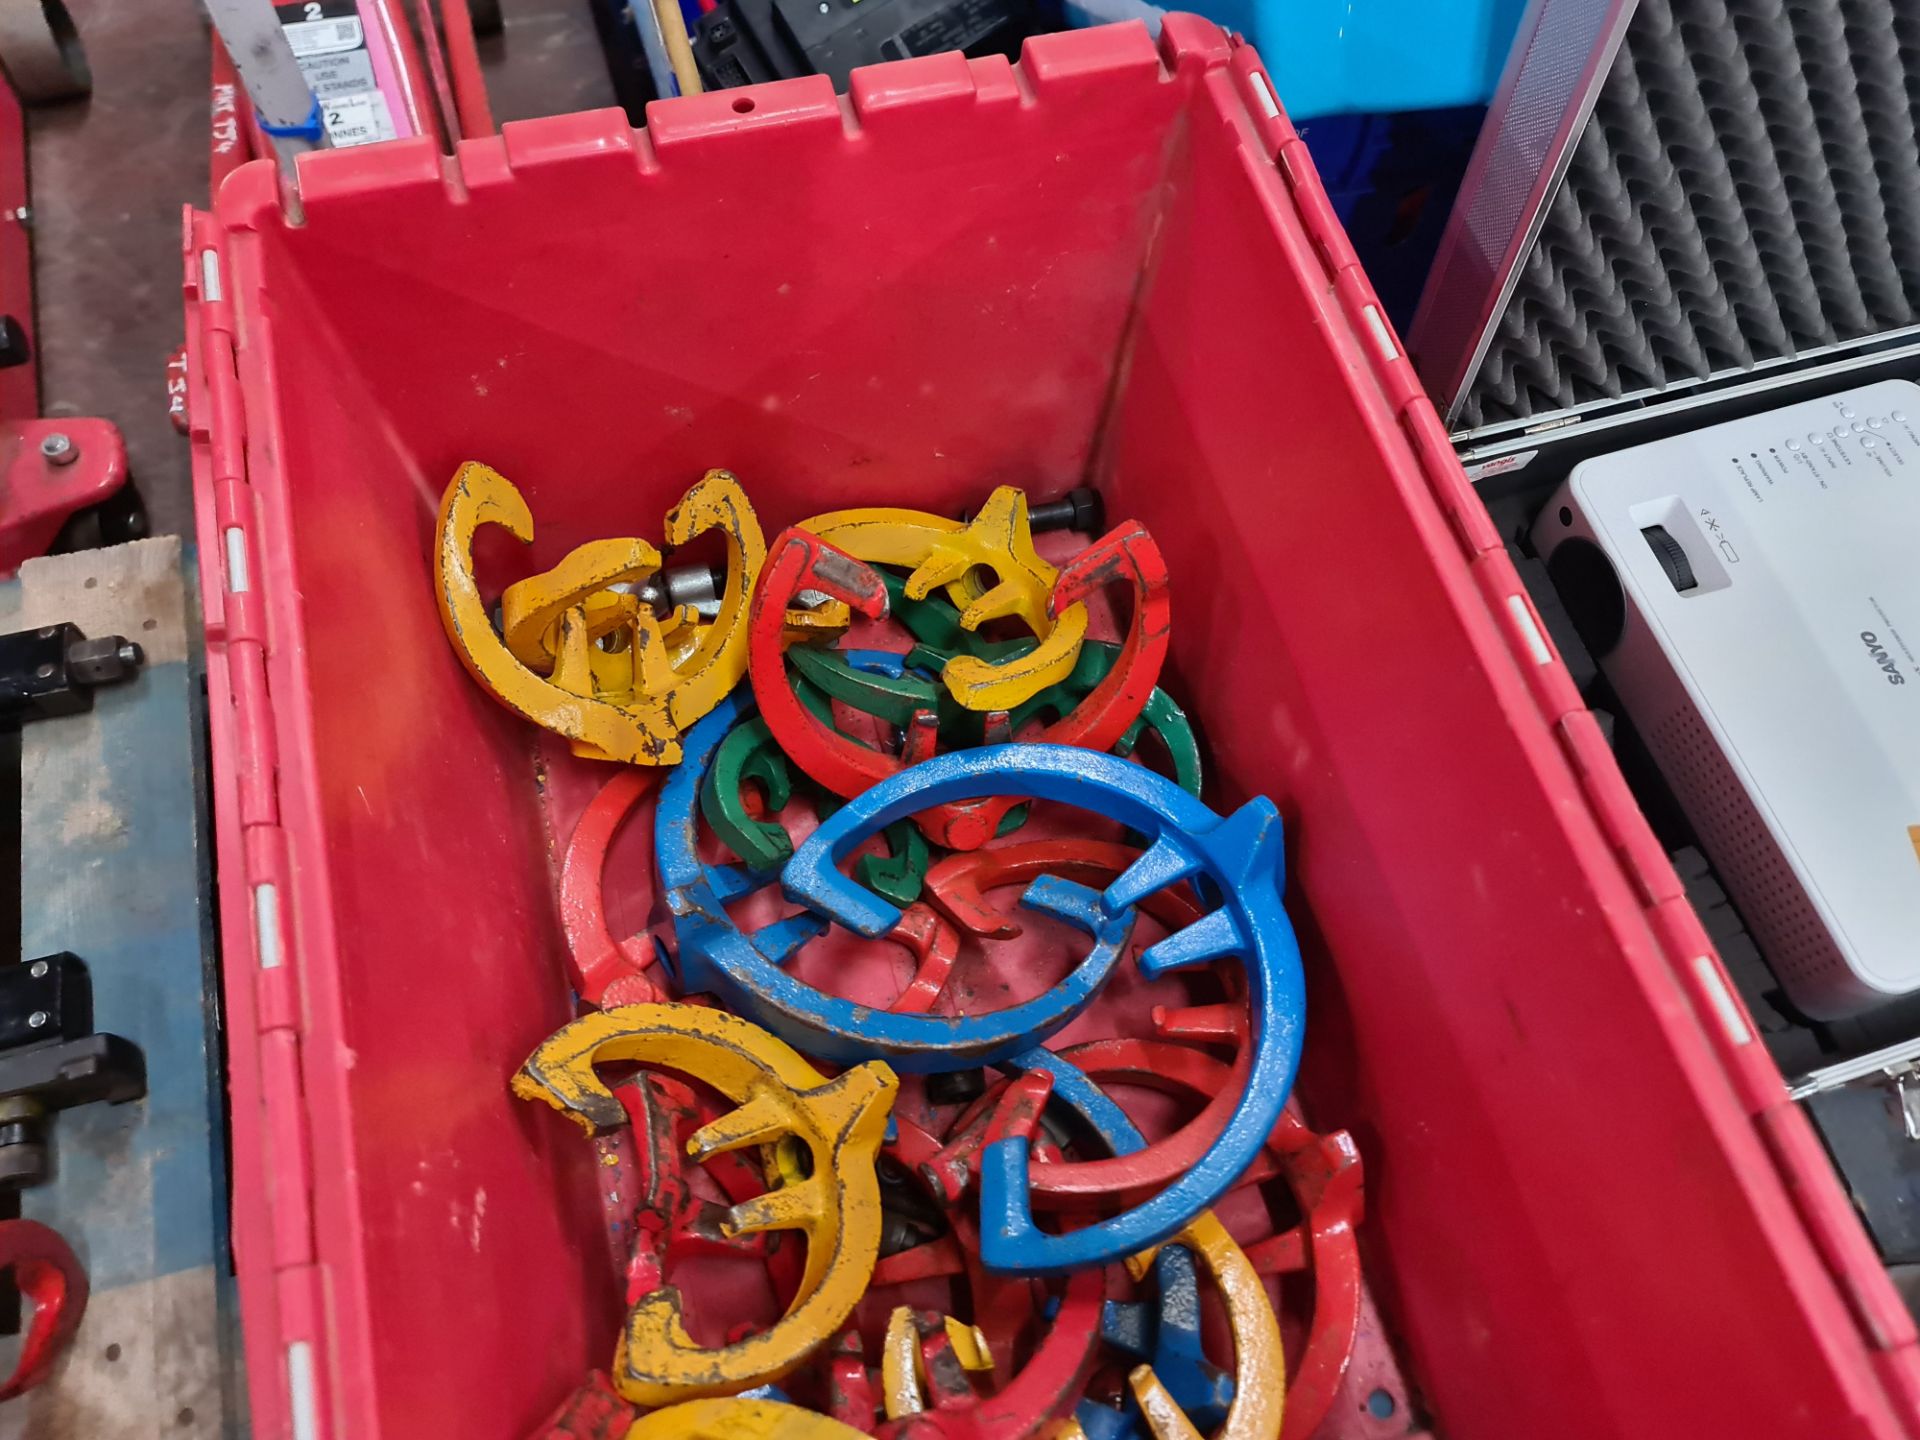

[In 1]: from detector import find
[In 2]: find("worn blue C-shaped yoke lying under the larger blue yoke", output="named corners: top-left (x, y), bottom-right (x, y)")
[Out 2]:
top-left (655, 687), bottom-right (1135, 1073)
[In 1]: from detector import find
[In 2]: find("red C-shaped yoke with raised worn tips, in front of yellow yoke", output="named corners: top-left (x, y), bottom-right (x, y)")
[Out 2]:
top-left (749, 522), bottom-right (1169, 851)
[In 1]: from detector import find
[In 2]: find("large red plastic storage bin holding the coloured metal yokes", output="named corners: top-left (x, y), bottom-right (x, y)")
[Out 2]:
top-left (186, 17), bottom-right (1920, 1440)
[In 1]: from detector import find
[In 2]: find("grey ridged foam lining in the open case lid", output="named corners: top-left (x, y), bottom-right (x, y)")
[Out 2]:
top-left (1461, 0), bottom-right (1920, 428)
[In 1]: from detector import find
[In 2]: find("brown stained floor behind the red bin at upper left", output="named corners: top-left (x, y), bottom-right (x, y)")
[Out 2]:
top-left (27, 0), bottom-right (612, 534)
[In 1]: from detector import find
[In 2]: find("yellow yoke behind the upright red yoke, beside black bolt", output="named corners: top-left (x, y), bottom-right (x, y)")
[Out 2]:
top-left (799, 486), bottom-right (1087, 710)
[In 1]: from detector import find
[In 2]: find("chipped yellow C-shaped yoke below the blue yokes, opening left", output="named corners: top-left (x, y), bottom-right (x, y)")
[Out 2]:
top-left (513, 1004), bottom-right (899, 1405)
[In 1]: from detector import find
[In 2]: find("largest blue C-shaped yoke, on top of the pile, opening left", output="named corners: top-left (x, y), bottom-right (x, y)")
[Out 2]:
top-left (781, 745), bottom-right (1306, 1275)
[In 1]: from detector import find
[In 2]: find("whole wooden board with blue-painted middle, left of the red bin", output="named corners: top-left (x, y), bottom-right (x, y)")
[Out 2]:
top-left (0, 540), bottom-right (244, 1440)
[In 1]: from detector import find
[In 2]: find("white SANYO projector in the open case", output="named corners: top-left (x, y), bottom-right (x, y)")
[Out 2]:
top-left (1534, 380), bottom-right (1920, 1020)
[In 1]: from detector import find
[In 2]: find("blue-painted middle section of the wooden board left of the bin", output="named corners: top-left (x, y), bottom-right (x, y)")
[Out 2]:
top-left (19, 664), bottom-right (227, 1290)
